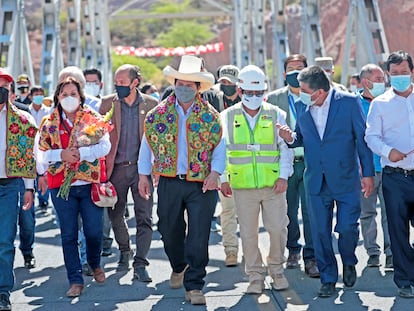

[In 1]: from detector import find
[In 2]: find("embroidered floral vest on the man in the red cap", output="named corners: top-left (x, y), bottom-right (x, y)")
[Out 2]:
top-left (6, 104), bottom-right (37, 178)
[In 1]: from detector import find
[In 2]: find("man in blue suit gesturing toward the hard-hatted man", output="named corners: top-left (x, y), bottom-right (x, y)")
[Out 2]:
top-left (278, 66), bottom-right (374, 297)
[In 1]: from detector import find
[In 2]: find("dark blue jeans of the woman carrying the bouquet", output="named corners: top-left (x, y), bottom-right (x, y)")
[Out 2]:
top-left (50, 184), bottom-right (103, 284)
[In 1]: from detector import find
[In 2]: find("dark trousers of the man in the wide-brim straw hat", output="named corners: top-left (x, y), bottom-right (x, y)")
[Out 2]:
top-left (157, 177), bottom-right (217, 291)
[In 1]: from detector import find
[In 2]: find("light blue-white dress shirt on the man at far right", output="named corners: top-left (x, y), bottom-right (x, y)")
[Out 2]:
top-left (365, 88), bottom-right (414, 170)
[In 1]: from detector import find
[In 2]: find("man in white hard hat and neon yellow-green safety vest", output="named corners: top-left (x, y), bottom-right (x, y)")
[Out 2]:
top-left (221, 65), bottom-right (293, 294)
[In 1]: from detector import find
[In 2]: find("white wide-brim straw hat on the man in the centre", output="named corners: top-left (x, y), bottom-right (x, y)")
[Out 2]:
top-left (163, 55), bottom-right (214, 93)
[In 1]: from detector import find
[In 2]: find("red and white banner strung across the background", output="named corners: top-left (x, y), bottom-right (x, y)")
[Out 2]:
top-left (114, 42), bottom-right (224, 57)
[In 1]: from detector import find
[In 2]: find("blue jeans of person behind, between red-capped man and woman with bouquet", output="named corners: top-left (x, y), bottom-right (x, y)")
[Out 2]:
top-left (18, 179), bottom-right (36, 256)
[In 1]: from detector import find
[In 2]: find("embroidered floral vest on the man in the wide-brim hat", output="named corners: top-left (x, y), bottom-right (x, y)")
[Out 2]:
top-left (144, 94), bottom-right (222, 182)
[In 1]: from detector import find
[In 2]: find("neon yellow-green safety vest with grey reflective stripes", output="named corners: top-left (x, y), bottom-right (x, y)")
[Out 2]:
top-left (226, 103), bottom-right (280, 189)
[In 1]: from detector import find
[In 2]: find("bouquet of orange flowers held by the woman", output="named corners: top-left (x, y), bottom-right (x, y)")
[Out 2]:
top-left (57, 103), bottom-right (114, 200)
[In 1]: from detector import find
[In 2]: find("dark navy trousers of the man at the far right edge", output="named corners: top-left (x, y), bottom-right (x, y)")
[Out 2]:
top-left (382, 171), bottom-right (414, 287)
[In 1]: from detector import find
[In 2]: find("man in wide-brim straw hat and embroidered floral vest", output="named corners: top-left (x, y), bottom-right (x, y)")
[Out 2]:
top-left (138, 55), bottom-right (226, 305)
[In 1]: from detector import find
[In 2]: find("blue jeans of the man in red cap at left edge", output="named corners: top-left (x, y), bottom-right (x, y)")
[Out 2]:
top-left (0, 178), bottom-right (20, 296)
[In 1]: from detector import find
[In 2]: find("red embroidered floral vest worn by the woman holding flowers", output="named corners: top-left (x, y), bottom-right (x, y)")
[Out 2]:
top-left (39, 108), bottom-right (100, 183)
